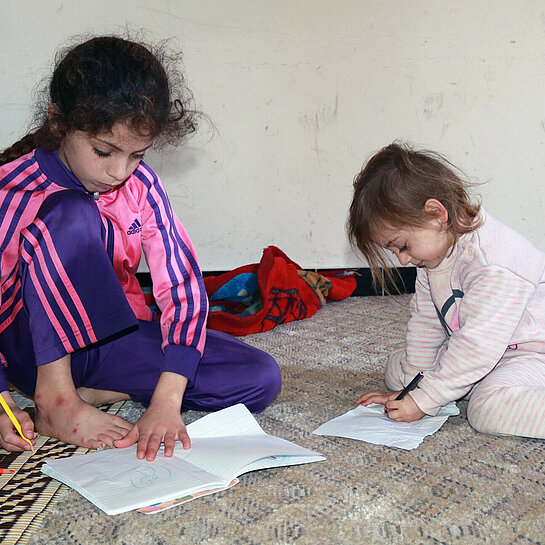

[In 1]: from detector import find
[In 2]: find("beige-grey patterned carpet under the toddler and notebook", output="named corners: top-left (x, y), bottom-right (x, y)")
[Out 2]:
top-left (2, 297), bottom-right (545, 545)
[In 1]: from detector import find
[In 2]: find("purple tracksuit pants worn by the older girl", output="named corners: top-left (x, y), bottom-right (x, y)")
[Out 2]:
top-left (0, 191), bottom-right (281, 412)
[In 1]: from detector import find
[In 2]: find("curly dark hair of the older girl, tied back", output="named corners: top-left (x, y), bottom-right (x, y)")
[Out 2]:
top-left (0, 36), bottom-right (197, 165)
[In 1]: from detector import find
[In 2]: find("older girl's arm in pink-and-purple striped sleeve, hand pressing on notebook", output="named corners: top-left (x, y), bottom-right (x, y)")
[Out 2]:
top-left (122, 163), bottom-right (208, 460)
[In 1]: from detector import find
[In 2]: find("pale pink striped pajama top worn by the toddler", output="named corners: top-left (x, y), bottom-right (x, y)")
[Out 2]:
top-left (401, 210), bottom-right (545, 415)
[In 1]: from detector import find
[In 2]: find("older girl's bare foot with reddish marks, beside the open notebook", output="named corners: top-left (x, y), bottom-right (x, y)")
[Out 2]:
top-left (36, 395), bottom-right (133, 449)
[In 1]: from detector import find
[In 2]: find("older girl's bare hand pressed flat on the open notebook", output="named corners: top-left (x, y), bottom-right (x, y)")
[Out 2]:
top-left (114, 372), bottom-right (191, 462)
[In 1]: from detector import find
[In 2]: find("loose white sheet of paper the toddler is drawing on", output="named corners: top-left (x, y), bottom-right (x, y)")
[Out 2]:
top-left (312, 402), bottom-right (460, 450)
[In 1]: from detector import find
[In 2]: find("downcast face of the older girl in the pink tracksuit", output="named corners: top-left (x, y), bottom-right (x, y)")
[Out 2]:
top-left (58, 123), bottom-right (153, 193)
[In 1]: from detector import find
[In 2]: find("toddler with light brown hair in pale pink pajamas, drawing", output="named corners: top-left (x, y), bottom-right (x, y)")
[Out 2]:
top-left (348, 143), bottom-right (545, 438)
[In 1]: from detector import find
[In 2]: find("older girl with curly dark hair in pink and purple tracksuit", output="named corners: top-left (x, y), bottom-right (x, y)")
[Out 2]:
top-left (0, 36), bottom-right (280, 460)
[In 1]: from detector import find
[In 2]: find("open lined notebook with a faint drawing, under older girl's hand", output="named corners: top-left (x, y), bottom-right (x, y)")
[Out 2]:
top-left (41, 404), bottom-right (325, 515)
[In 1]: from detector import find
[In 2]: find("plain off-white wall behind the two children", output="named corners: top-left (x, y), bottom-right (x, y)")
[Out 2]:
top-left (0, 0), bottom-right (545, 270)
